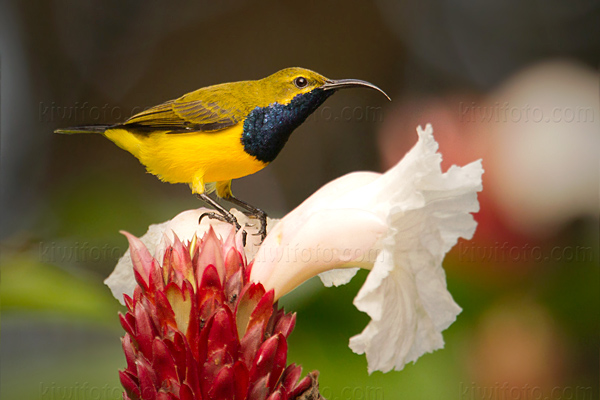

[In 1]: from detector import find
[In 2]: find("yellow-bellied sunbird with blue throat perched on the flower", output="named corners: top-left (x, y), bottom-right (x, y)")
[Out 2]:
top-left (54, 67), bottom-right (391, 240)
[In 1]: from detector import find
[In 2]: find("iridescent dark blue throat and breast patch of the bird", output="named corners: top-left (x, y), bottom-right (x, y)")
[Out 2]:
top-left (242, 88), bottom-right (334, 163)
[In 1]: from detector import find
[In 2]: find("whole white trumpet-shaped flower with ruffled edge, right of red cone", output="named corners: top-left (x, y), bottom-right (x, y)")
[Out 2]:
top-left (251, 125), bottom-right (483, 373)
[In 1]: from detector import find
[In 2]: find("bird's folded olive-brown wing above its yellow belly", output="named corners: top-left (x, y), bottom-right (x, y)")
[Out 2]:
top-left (122, 96), bottom-right (239, 133)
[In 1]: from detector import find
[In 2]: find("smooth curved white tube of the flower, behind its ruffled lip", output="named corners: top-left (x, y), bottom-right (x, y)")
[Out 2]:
top-left (251, 209), bottom-right (387, 298)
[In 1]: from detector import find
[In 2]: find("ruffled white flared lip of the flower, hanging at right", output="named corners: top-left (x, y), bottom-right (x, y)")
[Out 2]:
top-left (350, 125), bottom-right (483, 372)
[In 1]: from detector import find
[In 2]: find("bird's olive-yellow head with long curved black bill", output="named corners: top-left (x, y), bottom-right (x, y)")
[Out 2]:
top-left (258, 67), bottom-right (390, 105)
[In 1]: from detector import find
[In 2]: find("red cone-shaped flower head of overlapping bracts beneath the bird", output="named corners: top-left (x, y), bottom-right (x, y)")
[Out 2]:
top-left (119, 229), bottom-right (318, 400)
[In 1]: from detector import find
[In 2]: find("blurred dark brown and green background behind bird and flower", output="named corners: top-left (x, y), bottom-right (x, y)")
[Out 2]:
top-left (0, 0), bottom-right (600, 400)
